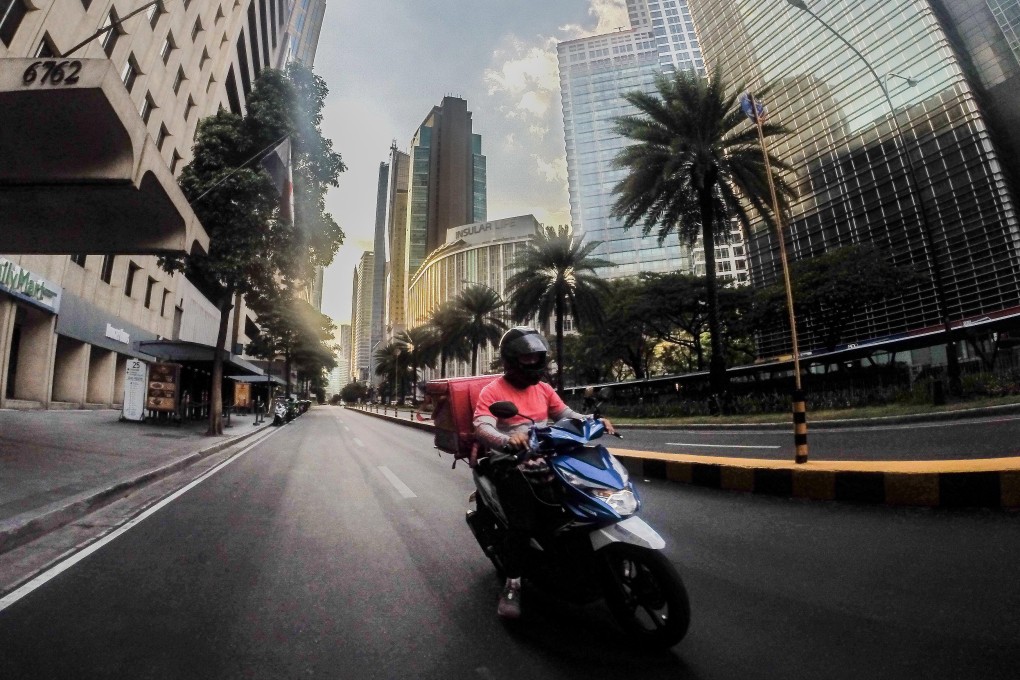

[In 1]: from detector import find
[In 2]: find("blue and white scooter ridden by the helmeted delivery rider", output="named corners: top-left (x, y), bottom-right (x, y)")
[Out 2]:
top-left (467, 402), bottom-right (691, 648)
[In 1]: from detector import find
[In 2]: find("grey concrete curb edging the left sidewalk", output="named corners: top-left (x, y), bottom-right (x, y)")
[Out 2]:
top-left (0, 423), bottom-right (268, 553)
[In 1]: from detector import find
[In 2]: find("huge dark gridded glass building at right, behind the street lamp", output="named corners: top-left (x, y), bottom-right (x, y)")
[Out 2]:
top-left (691, 0), bottom-right (1020, 357)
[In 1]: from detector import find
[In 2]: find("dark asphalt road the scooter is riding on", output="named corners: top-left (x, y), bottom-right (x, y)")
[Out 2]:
top-left (0, 409), bottom-right (1020, 680)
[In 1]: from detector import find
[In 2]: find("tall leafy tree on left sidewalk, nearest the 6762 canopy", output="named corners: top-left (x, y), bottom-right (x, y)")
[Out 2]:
top-left (162, 66), bottom-right (345, 434)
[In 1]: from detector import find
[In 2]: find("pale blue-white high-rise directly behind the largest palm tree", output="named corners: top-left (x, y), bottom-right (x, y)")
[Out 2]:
top-left (557, 0), bottom-right (748, 282)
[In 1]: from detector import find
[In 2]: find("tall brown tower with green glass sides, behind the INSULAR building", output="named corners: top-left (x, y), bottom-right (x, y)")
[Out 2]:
top-left (404, 97), bottom-right (486, 281)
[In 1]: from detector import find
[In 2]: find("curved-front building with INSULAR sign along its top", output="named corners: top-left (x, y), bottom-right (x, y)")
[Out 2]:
top-left (407, 215), bottom-right (540, 377)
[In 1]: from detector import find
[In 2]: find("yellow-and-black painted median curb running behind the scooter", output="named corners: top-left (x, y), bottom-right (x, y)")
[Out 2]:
top-left (352, 405), bottom-right (1020, 509)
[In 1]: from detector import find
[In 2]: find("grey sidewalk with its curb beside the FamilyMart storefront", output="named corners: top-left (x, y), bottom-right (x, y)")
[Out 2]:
top-left (0, 410), bottom-right (268, 553)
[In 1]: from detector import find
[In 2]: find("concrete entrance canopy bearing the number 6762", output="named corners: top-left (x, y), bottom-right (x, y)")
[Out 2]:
top-left (0, 59), bottom-right (209, 254)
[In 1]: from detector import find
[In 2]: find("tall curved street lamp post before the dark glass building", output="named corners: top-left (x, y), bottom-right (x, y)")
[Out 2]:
top-left (786, 0), bottom-right (960, 394)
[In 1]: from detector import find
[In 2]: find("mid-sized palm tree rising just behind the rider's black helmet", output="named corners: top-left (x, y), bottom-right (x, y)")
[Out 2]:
top-left (507, 226), bottom-right (615, 389)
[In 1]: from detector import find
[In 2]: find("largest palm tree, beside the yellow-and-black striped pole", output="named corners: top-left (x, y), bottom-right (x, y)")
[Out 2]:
top-left (612, 70), bottom-right (793, 395)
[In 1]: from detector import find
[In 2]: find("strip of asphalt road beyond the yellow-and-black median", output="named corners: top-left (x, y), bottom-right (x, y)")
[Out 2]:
top-left (618, 415), bottom-right (1020, 461)
